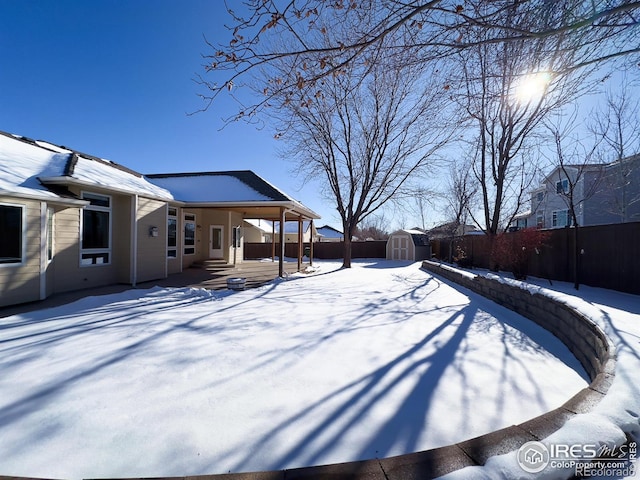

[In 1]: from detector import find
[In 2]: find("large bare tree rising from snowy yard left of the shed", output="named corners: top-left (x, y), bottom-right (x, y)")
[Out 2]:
top-left (273, 44), bottom-right (451, 268)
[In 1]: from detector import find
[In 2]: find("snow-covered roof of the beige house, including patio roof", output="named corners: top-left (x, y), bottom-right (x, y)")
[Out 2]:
top-left (0, 132), bottom-right (320, 220)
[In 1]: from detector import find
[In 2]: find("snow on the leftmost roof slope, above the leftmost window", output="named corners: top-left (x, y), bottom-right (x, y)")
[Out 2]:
top-left (0, 134), bottom-right (69, 199)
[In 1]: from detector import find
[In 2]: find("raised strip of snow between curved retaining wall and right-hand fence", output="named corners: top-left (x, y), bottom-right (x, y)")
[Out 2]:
top-left (442, 272), bottom-right (640, 480)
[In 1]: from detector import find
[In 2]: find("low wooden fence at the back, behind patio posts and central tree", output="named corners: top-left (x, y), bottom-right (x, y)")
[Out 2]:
top-left (244, 240), bottom-right (387, 260)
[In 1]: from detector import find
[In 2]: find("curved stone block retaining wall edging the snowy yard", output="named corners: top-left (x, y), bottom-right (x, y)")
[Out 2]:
top-left (74, 261), bottom-right (616, 480)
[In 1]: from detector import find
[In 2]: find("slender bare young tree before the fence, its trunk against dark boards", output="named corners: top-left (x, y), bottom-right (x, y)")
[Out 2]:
top-left (545, 109), bottom-right (605, 290)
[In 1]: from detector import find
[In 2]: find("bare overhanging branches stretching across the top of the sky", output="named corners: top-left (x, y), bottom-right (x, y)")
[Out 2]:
top-left (198, 0), bottom-right (640, 118)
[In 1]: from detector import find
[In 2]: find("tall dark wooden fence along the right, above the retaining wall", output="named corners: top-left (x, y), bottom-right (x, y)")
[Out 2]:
top-left (432, 222), bottom-right (640, 295)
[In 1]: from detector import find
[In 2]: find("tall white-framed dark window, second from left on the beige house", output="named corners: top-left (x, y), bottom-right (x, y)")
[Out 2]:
top-left (80, 192), bottom-right (111, 265)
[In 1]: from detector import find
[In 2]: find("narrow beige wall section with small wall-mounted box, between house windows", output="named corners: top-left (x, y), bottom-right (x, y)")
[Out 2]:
top-left (136, 198), bottom-right (167, 282)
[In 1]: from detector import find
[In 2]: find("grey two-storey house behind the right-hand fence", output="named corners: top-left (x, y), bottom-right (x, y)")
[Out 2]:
top-left (511, 155), bottom-right (640, 228)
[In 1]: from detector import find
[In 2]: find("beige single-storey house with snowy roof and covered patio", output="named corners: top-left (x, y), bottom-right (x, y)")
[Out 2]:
top-left (0, 132), bottom-right (319, 306)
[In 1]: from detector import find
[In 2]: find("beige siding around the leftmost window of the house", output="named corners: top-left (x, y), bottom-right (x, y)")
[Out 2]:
top-left (0, 197), bottom-right (41, 306)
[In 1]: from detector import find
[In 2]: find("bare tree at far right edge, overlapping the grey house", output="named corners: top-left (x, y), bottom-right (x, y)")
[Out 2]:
top-left (590, 75), bottom-right (640, 222)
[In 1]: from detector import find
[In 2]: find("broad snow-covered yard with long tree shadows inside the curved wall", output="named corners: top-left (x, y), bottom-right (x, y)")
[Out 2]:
top-left (0, 261), bottom-right (640, 478)
